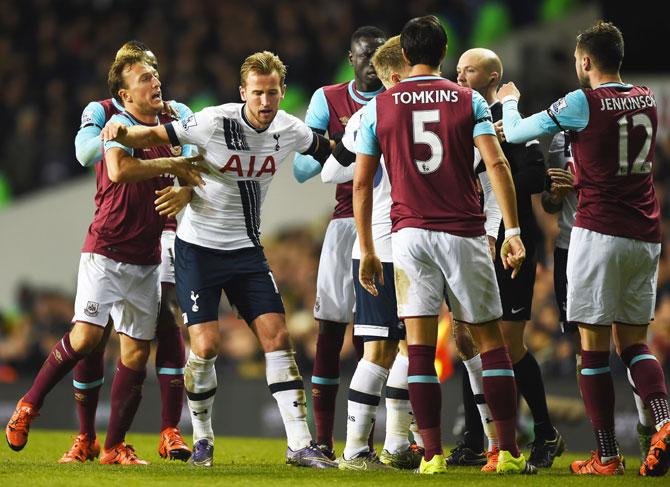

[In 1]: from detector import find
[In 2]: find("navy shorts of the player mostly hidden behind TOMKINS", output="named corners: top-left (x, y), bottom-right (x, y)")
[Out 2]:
top-left (352, 259), bottom-right (405, 342)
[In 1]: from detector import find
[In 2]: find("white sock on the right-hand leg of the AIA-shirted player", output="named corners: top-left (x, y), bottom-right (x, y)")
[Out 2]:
top-left (265, 350), bottom-right (312, 451)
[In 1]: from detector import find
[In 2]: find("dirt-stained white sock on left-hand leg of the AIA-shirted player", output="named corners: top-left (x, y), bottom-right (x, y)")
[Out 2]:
top-left (184, 351), bottom-right (216, 443)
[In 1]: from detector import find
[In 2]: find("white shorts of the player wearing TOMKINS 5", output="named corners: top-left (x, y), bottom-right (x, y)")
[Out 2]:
top-left (392, 228), bottom-right (502, 324)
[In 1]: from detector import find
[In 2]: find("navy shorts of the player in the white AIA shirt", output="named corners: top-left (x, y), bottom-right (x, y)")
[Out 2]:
top-left (175, 237), bottom-right (284, 326)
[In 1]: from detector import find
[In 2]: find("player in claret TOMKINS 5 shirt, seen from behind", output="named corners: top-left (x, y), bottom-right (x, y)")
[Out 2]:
top-left (353, 16), bottom-right (536, 474)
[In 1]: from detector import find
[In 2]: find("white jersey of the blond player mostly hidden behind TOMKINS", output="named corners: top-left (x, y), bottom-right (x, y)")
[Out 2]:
top-left (322, 110), bottom-right (393, 262)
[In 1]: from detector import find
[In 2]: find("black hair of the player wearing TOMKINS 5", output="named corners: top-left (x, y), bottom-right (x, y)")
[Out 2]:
top-left (400, 15), bottom-right (447, 68)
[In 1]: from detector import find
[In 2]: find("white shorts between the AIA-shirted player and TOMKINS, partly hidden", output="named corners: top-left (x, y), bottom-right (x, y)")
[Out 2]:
top-left (314, 218), bottom-right (356, 323)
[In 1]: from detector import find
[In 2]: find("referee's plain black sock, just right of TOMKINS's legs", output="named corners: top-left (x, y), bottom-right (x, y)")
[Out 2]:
top-left (514, 352), bottom-right (555, 440)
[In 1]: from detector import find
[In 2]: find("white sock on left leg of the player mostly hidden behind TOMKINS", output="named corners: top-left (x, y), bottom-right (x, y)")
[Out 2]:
top-left (342, 359), bottom-right (389, 460)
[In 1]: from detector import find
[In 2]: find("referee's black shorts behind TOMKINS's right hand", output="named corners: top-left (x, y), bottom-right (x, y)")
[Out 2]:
top-left (495, 235), bottom-right (537, 321)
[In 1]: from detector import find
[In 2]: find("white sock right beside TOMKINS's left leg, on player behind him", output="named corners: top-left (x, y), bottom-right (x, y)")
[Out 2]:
top-left (384, 354), bottom-right (412, 453)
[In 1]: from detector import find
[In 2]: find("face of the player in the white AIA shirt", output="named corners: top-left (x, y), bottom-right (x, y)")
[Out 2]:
top-left (240, 71), bottom-right (286, 129)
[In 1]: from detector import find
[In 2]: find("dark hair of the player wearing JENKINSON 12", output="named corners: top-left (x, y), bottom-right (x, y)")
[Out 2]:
top-left (577, 20), bottom-right (623, 74)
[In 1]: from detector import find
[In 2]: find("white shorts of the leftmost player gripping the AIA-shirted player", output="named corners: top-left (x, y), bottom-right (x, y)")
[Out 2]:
top-left (72, 252), bottom-right (161, 340)
